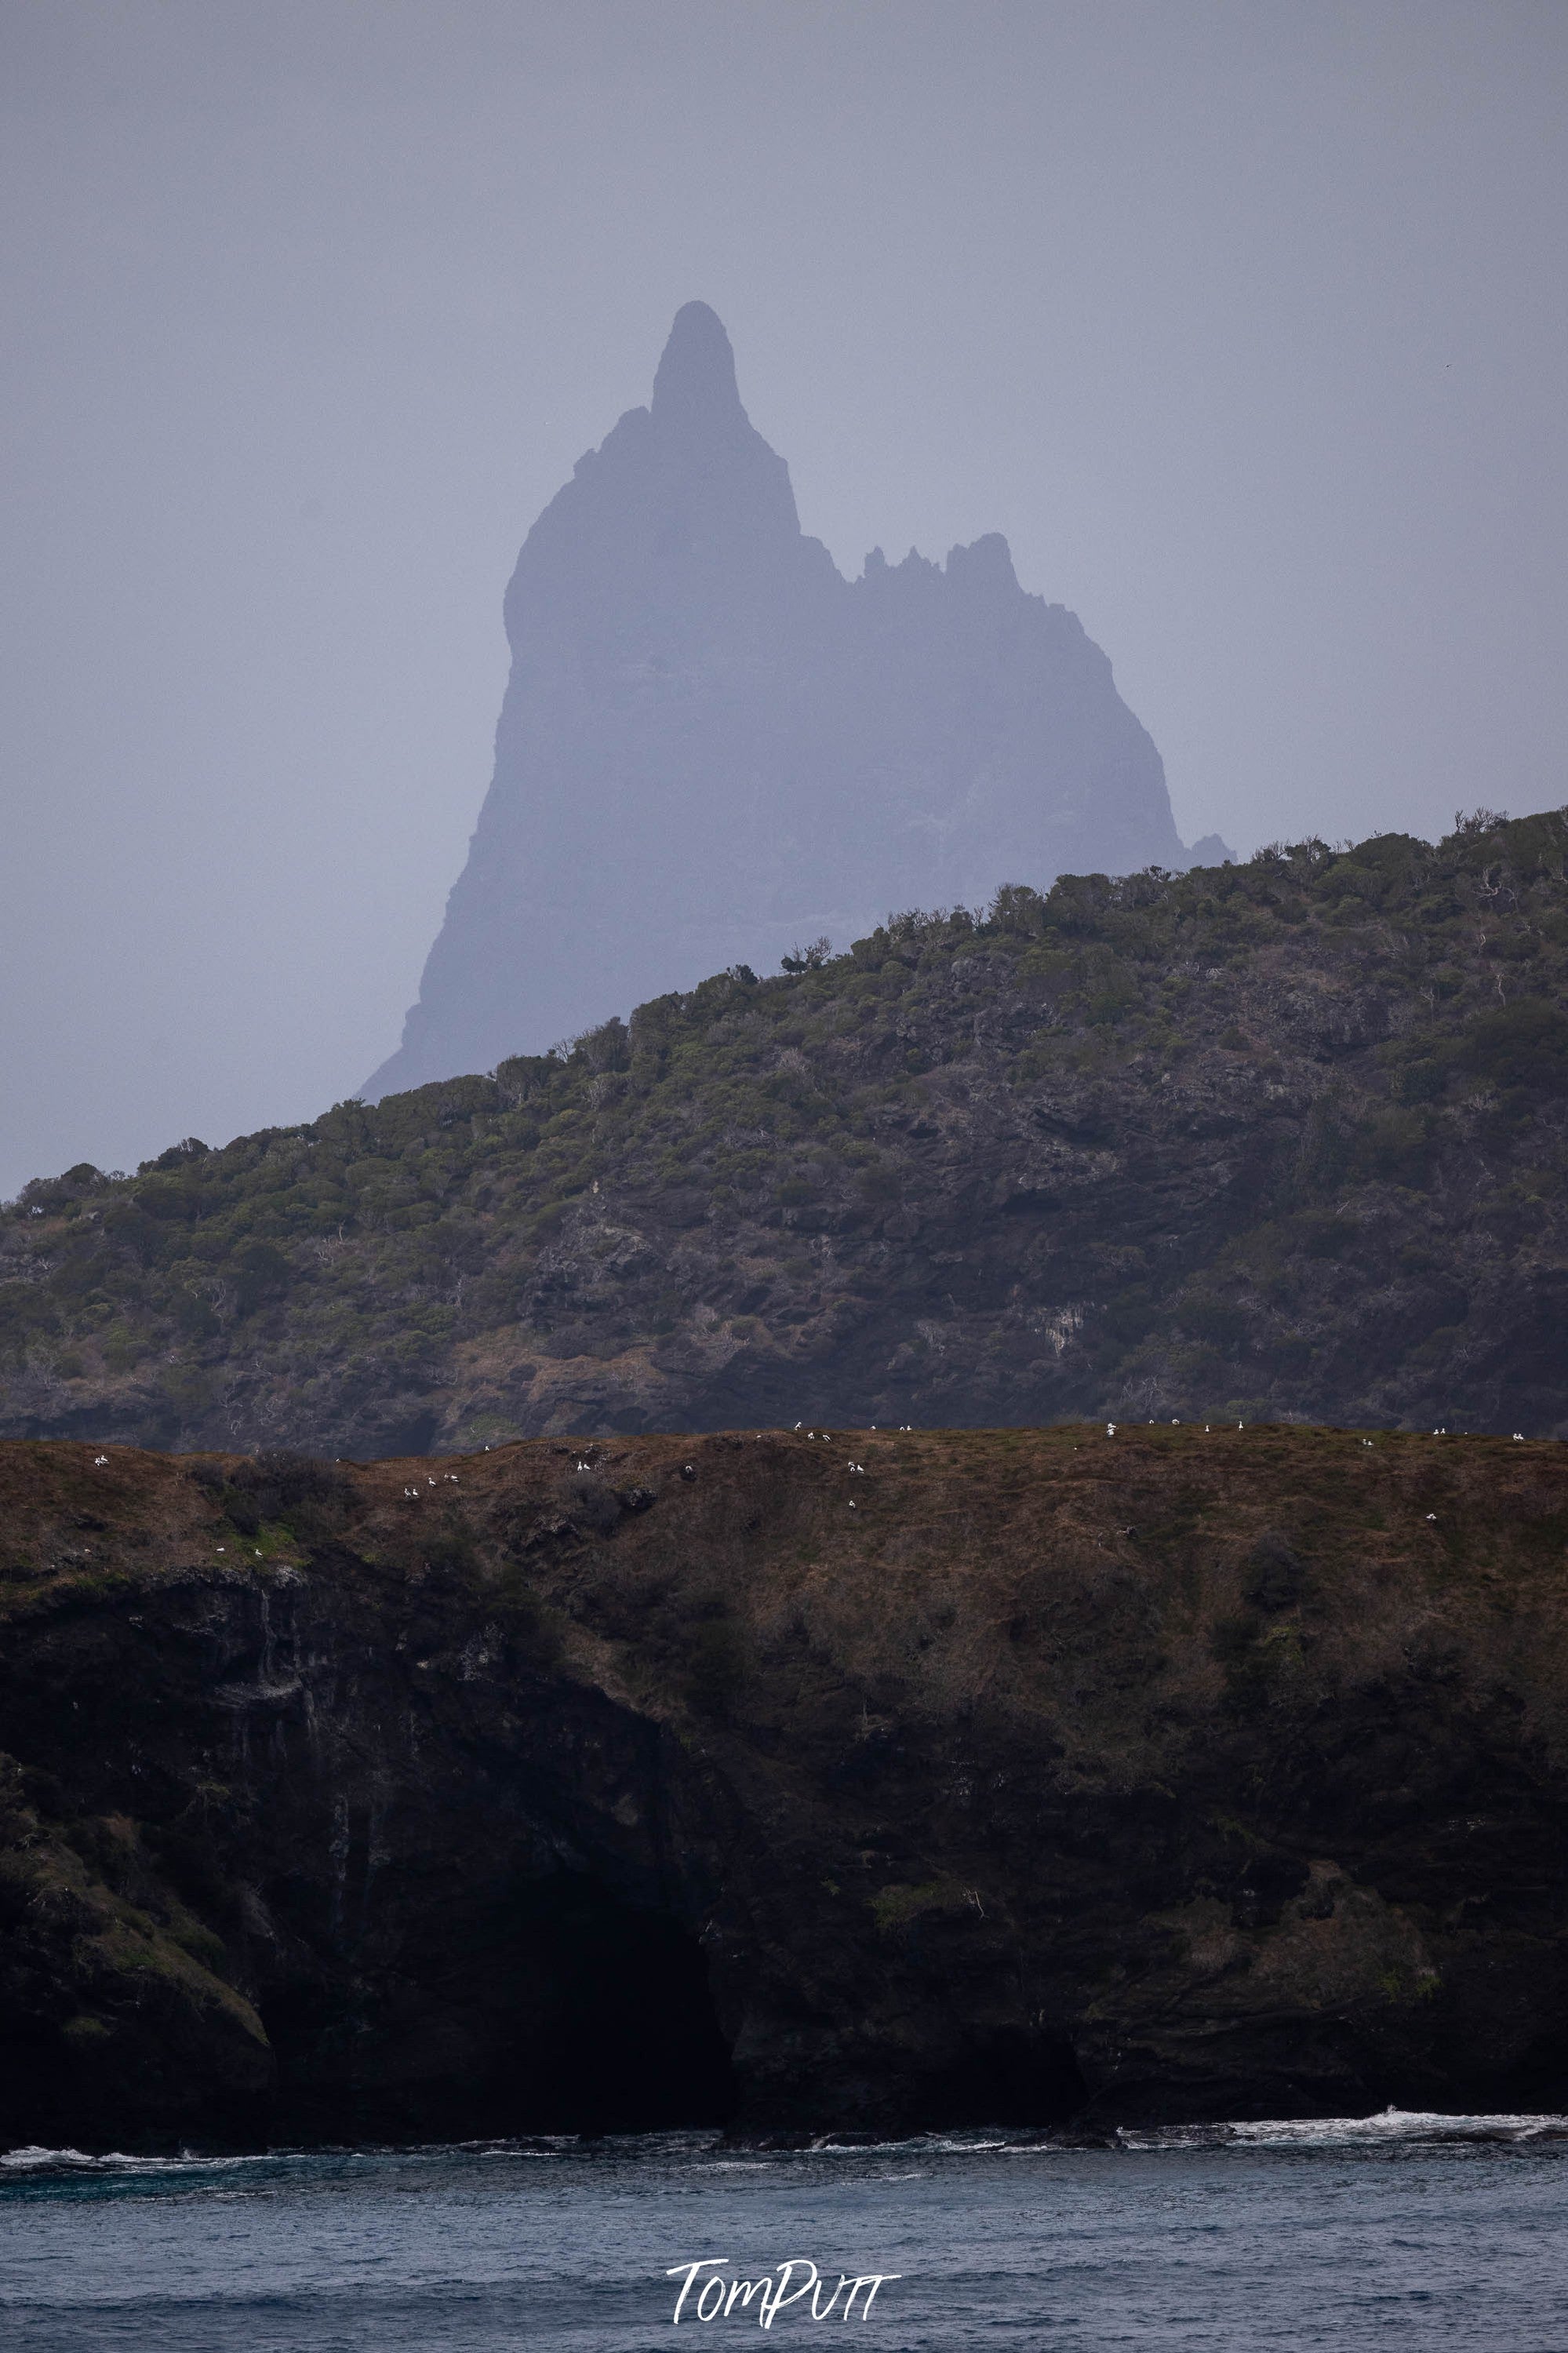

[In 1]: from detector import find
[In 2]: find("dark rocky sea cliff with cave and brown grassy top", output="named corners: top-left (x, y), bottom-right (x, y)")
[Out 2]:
top-left (0, 1426), bottom-right (1568, 2146)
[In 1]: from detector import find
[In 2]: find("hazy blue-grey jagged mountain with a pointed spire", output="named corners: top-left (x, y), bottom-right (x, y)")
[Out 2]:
top-left (365, 301), bottom-right (1227, 1099)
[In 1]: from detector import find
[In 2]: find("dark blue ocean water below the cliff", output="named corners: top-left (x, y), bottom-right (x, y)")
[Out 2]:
top-left (0, 2111), bottom-right (1568, 2353)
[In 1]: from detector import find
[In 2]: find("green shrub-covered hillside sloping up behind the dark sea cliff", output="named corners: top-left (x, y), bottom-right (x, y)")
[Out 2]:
top-left (0, 812), bottom-right (1568, 1454)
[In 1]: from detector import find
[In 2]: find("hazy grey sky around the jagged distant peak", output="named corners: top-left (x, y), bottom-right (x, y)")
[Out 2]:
top-left (0, 0), bottom-right (1568, 1195)
